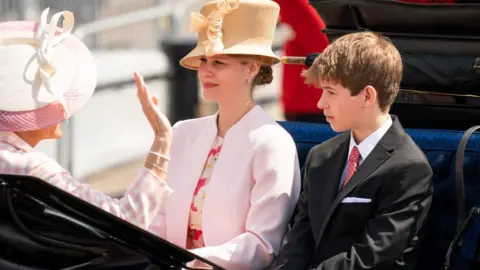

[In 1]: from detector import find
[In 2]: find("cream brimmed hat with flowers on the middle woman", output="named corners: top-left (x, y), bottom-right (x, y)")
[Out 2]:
top-left (180, 0), bottom-right (280, 70)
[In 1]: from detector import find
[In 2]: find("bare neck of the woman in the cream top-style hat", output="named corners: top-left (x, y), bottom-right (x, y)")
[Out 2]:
top-left (217, 100), bottom-right (256, 138)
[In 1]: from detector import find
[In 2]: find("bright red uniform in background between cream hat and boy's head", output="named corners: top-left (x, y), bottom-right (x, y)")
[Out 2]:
top-left (274, 0), bottom-right (328, 123)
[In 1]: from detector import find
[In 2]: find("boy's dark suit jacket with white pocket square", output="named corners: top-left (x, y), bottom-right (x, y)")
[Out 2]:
top-left (270, 116), bottom-right (433, 270)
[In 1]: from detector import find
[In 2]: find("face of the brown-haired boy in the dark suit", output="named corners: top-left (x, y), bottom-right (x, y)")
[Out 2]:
top-left (317, 82), bottom-right (365, 132)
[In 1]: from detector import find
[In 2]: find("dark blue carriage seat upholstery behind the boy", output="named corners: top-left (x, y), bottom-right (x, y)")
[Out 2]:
top-left (280, 122), bottom-right (480, 270)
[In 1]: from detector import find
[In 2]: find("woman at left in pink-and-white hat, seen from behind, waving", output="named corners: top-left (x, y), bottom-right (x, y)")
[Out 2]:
top-left (0, 9), bottom-right (171, 232)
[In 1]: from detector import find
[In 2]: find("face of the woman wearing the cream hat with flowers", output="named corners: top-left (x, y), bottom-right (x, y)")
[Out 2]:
top-left (198, 55), bottom-right (260, 102)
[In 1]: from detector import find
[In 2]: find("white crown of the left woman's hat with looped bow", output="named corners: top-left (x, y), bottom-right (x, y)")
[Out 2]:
top-left (0, 8), bottom-right (74, 114)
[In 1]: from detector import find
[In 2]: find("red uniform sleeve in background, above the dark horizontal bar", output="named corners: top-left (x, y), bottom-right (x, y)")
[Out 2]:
top-left (275, 0), bottom-right (328, 53)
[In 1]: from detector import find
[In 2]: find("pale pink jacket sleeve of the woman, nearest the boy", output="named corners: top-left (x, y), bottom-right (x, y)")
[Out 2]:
top-left (191, 132), bottom-right (300, 269)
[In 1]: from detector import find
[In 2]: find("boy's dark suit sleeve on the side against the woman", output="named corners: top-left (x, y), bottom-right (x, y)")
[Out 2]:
top-left (269, 151), bottom-right (315, 269)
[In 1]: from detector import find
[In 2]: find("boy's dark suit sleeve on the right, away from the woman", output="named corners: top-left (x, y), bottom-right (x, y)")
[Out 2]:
top-left (315, 161), bottom-right (433, 270)
